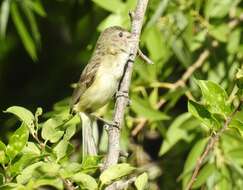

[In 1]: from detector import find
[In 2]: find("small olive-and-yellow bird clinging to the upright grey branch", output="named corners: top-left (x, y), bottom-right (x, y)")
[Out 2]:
top-left (70, 26), bottom-right (131, 156)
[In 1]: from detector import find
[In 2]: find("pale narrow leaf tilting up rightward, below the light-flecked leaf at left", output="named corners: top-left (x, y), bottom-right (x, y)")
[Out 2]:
top-left (16, 161), bottom-right (44, 184)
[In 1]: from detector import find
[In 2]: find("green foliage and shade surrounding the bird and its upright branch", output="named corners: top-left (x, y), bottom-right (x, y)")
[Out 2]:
top-left (0, 0), bottom-right (243, 190)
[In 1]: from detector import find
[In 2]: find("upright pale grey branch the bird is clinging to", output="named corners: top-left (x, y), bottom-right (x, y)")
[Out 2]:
top-left (103, 0), bottom-right (148, 169)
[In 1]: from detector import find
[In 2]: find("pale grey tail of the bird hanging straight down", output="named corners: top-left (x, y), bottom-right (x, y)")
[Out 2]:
top-left (79, 113), bottom-right (97, 158)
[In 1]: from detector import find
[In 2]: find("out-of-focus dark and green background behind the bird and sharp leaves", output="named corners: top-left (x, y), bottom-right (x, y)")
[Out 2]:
top-left (0, 0), bottom-right (243, 190)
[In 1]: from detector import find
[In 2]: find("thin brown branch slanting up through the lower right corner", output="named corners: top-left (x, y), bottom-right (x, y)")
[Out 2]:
top-left (186, 104), bottom-right (240, 190)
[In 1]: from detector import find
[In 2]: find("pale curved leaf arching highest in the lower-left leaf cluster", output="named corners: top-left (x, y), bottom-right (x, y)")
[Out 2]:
top-left (5, 106), bottom-right (35, 132)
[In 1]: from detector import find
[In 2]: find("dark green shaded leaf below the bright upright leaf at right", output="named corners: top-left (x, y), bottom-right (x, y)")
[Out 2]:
top-left (188, 100), bottom-right (220, 129)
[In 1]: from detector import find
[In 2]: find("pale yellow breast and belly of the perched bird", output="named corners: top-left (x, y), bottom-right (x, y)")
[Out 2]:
top-left (77, 53), bottom-right (128, 111)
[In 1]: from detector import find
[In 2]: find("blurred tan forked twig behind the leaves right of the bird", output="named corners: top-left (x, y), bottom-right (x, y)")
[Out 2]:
top-left (132, 49), bottom-right (210, 136)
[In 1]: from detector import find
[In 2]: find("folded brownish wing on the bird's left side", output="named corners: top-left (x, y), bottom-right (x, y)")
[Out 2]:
top-left (70, 53), bottom-right (101, 109)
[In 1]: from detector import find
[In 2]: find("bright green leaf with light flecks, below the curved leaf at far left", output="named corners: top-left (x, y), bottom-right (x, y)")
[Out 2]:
top-left (6, 122), bottom-right (29, 160)
